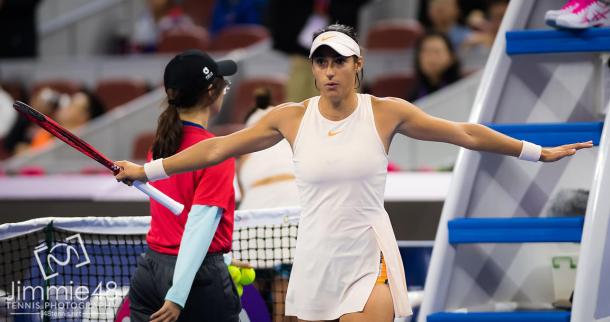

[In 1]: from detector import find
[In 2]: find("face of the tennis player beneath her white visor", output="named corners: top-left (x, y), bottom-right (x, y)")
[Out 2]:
top-left (311, 46), bottom-right (363, 98)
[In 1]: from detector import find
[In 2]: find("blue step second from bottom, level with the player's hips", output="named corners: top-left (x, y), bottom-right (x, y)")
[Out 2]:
top-left (448, 217), bottom-right (585, 244)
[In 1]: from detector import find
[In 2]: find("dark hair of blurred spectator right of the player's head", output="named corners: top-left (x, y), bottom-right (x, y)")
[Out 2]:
top-left (410, 31), bottom-right (462, 99)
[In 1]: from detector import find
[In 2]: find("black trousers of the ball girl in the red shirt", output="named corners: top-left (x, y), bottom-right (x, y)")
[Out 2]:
top-left (129, 250), bottom-right (241, 322)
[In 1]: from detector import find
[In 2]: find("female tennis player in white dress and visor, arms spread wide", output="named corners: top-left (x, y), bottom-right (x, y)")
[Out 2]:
top-left (116, 25), bottom-right (592, 322)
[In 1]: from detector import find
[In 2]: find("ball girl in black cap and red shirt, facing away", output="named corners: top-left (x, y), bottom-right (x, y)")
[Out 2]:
top-left (129, 50), bottom-right (241, 322)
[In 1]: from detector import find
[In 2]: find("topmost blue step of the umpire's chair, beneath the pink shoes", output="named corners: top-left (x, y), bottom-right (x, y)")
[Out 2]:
top-left (506, 28), bottom-right (610, 55)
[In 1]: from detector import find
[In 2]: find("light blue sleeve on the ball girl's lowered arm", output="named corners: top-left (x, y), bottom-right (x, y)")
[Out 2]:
top-left (165, 205), bottom-right (222, 308)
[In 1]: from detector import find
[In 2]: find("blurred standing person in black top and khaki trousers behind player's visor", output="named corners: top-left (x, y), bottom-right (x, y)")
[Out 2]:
top-left (267, 0), bottom-right (368, 102)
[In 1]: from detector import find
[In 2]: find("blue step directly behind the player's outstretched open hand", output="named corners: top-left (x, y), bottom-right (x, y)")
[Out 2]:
top-left (487, 122), bottom-right (604, 147)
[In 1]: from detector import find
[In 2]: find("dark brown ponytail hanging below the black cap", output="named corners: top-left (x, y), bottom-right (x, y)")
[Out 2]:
top-left (152, 104), bottom-right (182, 160)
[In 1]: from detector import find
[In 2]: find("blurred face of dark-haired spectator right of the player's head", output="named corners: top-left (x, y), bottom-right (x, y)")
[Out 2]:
top-left (418, 37), bottom-right (453, 78)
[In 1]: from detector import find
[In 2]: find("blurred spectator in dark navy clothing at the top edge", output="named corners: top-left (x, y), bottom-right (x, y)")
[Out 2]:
top-left (210, 0), bottom-right (267, 36)
